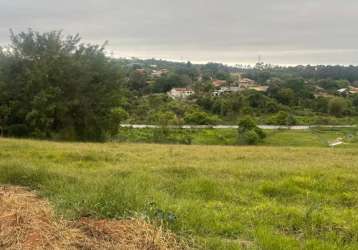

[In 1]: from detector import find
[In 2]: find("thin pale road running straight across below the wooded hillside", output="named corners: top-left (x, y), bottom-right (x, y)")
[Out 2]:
top-left (121, 124), bottom-right (357, 130)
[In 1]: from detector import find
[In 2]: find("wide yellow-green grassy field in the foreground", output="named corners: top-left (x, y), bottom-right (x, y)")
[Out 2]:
top-left (0, 138), bottom-right (358, 250)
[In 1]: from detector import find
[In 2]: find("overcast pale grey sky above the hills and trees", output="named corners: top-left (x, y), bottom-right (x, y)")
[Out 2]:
top-left (0, 0), bottom-right (358, 64)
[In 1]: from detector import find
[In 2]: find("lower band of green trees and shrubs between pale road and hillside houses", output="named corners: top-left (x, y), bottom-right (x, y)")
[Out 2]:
top-left (126, 87), bottom-right (358, 125)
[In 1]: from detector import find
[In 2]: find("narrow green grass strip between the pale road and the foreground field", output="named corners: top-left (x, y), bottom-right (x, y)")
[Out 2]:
top-left (118, 128), bottom-right (358, 147)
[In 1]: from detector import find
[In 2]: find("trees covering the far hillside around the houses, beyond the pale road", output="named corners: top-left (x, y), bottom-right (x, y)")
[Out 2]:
top-left (120, 59), bottom-right (358, 125)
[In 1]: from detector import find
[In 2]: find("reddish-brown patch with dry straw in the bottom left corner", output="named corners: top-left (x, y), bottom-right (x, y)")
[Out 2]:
top-left (0, 186), bottom-right (183, 250)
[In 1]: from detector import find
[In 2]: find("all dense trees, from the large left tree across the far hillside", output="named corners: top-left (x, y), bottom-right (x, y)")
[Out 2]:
top-left (0, 30), bottom-right (358, 140)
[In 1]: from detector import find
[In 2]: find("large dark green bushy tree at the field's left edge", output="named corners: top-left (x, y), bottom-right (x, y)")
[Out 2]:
top-left (0, 30), bottom-right (122, 140)
